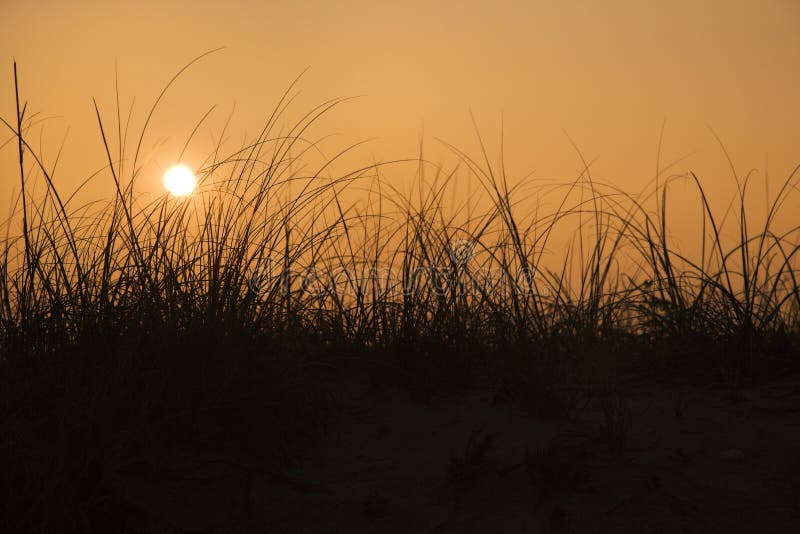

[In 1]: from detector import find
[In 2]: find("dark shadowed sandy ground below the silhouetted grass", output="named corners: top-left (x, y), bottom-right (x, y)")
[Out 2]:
top-left (117, 376), bottom-right (800, 532)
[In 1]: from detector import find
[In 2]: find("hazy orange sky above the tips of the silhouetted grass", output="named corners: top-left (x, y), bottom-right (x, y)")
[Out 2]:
top-left (0, 0), bottom-right (800, 253)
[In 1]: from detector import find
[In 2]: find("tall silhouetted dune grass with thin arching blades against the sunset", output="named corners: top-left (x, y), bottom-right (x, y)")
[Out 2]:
top-left (0, 58), bottom-right (800, 530)
